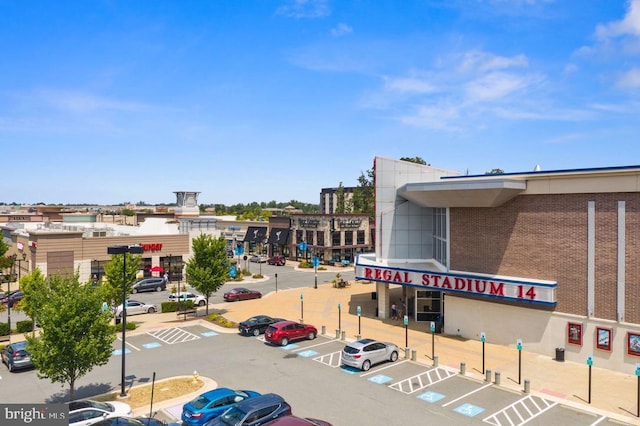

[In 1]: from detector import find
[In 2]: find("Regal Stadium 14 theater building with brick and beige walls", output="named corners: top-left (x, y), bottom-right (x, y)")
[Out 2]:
top-left (356, 157), bottom-right (640, 372)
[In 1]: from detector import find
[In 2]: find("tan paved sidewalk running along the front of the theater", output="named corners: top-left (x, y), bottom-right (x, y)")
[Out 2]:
top-left (134, 281), bottom-right (640, 424)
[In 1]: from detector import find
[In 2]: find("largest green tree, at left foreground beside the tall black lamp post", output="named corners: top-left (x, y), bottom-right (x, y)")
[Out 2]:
top-left (25, 274), bottom-right (116, 401)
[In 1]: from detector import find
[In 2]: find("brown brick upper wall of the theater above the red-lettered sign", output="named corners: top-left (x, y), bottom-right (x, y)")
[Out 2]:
top-left (450, 193), bottom-right (640, 323)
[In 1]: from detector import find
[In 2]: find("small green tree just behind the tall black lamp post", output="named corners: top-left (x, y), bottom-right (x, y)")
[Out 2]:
top-left (100, 253), bottom-right (141, 305)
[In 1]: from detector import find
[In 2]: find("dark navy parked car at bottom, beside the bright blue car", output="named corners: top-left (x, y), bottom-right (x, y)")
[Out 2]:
top-left (205, 393), bottom-right (291, 426)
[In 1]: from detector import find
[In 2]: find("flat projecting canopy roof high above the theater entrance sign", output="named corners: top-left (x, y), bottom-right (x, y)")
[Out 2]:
top-left (398, 178), bottom-right (527, 207)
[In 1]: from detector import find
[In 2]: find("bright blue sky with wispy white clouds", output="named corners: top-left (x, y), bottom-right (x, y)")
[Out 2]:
top-left (0, 0), bottom-right (640, 205)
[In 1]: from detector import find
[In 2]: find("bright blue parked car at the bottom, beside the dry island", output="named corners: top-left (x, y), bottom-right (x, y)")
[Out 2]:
top-left (182, 388), bottom-right (260, 426)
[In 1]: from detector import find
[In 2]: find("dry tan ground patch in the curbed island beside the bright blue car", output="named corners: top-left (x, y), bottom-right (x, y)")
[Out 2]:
top-left (92, 377), bottom-right (204, 409)
